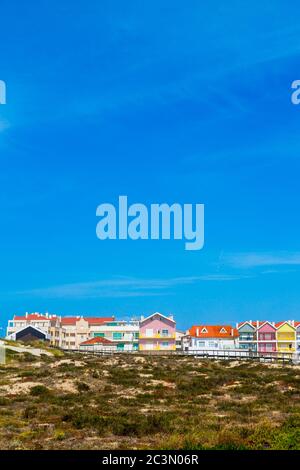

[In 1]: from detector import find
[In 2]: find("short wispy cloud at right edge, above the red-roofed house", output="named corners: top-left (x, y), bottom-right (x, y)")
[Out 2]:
top-left (222, 252), bottom-right (300, 268)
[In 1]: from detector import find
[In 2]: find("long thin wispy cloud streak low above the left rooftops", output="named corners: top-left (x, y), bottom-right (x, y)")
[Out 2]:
top-left (15, 274), bottom-right (245, 299)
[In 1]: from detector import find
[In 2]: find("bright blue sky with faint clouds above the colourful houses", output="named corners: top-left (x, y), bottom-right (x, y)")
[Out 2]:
top-left (0, 0), bottom-right (300, 333)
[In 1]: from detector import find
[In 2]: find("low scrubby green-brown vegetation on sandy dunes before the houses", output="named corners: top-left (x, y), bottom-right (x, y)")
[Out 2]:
top-left (0, 352), bottom-right (300, 450)
